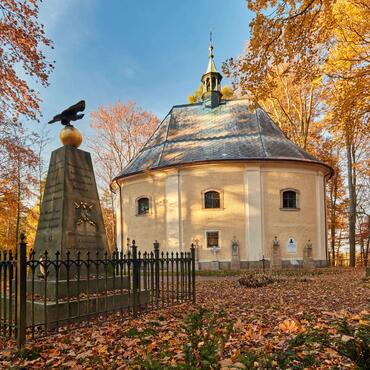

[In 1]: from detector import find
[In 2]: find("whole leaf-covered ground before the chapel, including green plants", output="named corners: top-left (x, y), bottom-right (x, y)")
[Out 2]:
top-left (0, 269), bottom-right (370, 369)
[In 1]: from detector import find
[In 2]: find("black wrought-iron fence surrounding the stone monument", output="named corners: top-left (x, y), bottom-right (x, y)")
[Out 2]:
top-left (0, 234), bottom-right (195, 348)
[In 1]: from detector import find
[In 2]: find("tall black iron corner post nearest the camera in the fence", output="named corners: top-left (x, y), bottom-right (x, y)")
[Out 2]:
top-left (17, 233), bottom-right (27, 349)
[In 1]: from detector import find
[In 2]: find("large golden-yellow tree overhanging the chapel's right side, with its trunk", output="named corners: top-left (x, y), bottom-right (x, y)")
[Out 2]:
top-left (223, 0), bottom-right (370, 266)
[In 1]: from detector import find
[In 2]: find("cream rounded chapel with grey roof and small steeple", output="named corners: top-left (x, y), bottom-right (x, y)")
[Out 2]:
top-left (112, 45), bottom-right (332, 269)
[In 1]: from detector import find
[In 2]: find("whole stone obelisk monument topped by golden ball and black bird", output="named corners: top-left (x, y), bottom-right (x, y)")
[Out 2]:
top-left (27, 100), bottom-right (148, 325)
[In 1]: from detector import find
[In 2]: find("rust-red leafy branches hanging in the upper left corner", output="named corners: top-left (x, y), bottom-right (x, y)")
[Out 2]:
top-left (0, 0), bottom-right (53, 125)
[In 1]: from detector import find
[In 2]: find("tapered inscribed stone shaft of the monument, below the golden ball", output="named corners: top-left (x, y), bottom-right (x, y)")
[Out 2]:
top-left (35, 146), bottom-right (107, 259)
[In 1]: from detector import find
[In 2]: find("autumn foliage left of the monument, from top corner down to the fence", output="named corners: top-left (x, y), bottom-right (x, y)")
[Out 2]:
top-left (0, 0), bottom-right (53, 249)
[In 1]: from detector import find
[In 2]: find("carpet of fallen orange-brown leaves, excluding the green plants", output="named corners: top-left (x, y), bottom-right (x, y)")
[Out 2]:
top-left (0, 269), bottom-right (369, 370)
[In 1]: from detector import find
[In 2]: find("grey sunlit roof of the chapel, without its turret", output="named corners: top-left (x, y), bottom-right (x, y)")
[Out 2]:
top-left (116, 99), bottom-right (329, 179)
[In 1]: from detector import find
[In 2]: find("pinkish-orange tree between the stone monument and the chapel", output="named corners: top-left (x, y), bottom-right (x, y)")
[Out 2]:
top-left (89, 101), bottom-right (159, 246)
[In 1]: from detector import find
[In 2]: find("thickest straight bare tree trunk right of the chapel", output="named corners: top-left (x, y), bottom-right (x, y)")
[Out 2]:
top-left (346, 137), bottom-right (356, 267)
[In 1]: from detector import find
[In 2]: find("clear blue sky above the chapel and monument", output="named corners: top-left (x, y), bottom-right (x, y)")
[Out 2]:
top-left (27, 0), bottom-right (252, 156)
